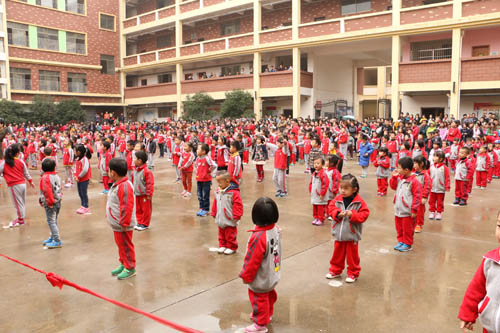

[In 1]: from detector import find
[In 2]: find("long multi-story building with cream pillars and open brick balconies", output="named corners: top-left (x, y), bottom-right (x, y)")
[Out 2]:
top-left (119, 0), bottom-right (500, 119)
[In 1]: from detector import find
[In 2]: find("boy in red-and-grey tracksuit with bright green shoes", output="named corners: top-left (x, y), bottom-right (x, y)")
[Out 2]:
top-left (106, 158), bottom-right (136, 280)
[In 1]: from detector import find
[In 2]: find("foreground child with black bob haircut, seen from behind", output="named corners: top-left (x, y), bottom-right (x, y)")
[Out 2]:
top-left (239, 197), bottom-right (281, 333)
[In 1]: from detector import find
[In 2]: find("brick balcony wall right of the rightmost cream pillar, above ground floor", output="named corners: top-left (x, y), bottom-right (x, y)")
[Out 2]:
top-left (461, 57), bottom-right (500, 82)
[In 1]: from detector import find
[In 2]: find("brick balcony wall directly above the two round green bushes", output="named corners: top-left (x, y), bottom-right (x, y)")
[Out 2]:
top-left (181, 75), bottom-right (253, 94)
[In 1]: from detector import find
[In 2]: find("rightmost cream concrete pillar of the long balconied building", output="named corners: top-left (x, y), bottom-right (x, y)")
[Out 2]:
top-left (450, 29), bottom-right (462, 119)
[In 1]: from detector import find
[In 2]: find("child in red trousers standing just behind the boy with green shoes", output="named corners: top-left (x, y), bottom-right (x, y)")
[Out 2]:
top-left (132, 151), bottom-right (155, 231)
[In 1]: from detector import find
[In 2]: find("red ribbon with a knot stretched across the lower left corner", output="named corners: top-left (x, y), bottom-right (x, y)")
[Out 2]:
top-left (0, 253), bottom-right (202, 333)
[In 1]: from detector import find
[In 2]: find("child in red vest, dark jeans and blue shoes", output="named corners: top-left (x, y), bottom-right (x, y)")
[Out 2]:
top-left (195, 143), bottom-right (217, 217)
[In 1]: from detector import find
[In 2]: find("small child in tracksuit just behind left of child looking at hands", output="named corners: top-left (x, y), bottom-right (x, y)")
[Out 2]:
top-left (309, 158), bottom-right (329, 226)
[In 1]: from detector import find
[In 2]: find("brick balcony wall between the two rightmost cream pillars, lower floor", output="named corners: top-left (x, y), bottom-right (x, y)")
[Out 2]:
top-left (399, 60), bottom-right (451, 83)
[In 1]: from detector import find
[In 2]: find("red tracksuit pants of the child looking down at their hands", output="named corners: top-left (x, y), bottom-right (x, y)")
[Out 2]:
top-left (330, 241), bottom-right (361, 278)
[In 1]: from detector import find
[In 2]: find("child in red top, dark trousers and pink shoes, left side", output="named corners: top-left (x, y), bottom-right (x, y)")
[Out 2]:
top-left (75, 144), bottom-right (92, 214)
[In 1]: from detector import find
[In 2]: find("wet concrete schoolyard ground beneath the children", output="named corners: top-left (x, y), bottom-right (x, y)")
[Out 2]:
top-left (0, 158), bottom-right (500, 332)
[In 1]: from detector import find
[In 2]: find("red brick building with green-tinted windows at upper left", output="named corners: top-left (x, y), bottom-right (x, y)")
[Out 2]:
top-left (4, 0), bottom-right (124, 116)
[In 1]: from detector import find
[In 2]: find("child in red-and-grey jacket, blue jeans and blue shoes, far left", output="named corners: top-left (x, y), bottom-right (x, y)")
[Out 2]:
top-left (39, 159), bottom-right (62, 249)
